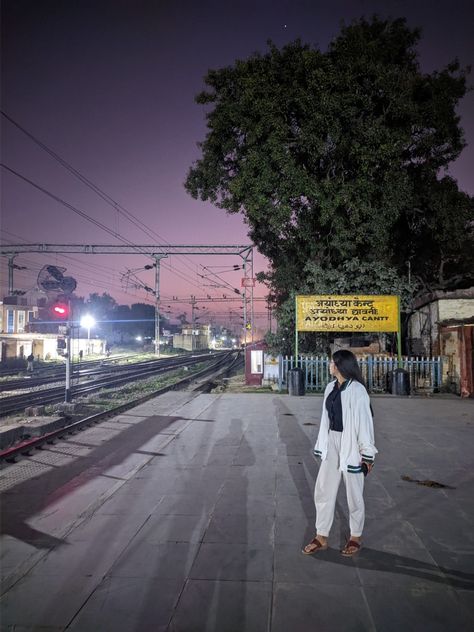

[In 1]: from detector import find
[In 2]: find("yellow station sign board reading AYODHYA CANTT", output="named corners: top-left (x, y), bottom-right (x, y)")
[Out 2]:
top-left (296, 295), bottom-right (399, 332)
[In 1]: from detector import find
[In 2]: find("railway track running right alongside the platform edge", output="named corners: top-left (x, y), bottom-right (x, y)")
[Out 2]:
top-left (0, 352), bottom-right (242, 464)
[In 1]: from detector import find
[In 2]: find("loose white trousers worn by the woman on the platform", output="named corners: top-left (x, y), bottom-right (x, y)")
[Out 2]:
top-left (314, 430), bottom-right (365, 537)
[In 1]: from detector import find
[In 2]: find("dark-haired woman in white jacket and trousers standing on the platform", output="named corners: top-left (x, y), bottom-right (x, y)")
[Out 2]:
top-left (303, 349), bottom-right (377, 556)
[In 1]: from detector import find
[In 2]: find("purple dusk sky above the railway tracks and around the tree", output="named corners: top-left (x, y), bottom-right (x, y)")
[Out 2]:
top-left (0, 0), bottom-right (474, 324)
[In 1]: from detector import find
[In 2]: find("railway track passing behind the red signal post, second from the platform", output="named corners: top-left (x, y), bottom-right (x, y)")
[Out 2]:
top-left (0, 352), bottom-right (227, 416)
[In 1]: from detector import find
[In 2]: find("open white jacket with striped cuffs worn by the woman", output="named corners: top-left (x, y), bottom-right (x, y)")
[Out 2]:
top-left (313, 380), bottom-right (378, 473)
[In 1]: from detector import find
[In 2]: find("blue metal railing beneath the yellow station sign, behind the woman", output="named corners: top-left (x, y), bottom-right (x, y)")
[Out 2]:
top-left (279, 355), bottom-right (443, 393)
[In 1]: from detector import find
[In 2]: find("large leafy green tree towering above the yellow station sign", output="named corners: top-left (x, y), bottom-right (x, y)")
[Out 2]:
top-left (185, 18), bottom-right (473, 305)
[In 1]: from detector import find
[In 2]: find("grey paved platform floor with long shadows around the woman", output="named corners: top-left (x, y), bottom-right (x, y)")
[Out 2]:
top-left (0, 392), bottom-right (474, 632)
